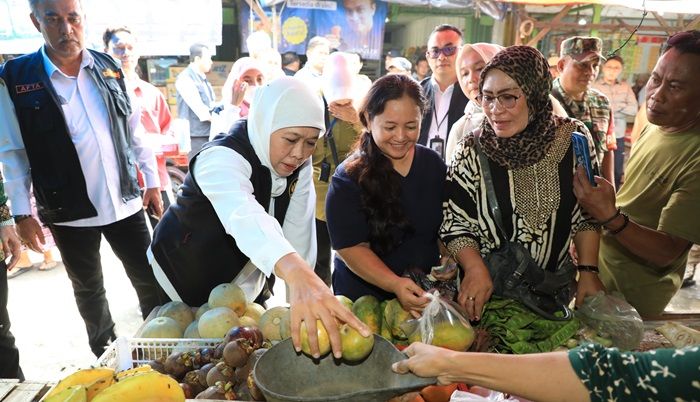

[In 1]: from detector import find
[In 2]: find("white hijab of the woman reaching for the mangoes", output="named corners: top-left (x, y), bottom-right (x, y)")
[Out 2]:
top-left (248, 77), bottom-right (326, 197)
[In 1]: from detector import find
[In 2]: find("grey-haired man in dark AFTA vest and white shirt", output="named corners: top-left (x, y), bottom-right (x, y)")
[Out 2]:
top-left (0, 0), bottom-right (167, 356)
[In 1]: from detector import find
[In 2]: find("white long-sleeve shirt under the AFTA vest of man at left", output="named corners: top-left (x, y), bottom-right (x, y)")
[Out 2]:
top-left (0, 47), bottom-right (160, 227)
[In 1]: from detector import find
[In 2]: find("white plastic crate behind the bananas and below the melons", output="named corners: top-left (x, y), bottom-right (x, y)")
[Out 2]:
top-left (97, 336), bottom-right (221, 371)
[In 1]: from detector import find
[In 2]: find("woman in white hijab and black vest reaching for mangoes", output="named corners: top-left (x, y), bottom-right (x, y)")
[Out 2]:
top-left (151, 77), bottom-right (369, 355)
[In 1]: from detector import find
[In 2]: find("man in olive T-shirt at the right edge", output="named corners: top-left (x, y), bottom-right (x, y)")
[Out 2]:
top-left (574, 30), bottom-right (700, 317)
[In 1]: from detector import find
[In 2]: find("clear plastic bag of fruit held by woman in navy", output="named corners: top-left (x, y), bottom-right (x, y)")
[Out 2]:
top-left (402, 291), bottom-right (474, 352)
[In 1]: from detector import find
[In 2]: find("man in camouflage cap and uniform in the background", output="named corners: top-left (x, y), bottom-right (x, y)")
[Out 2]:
top-left (552, 36), bottom-right (616, 183)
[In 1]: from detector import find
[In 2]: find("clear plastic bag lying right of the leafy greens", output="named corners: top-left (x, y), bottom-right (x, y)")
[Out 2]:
top-left (576, 292), bottom-right (644, 350)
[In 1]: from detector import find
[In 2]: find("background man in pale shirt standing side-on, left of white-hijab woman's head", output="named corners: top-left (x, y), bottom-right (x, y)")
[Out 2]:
top-left (175, 43), bottom-right (216, 159)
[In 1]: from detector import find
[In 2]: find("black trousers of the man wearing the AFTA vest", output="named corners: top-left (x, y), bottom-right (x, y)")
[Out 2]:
top-left (49, 211), bottom-right (168, 357)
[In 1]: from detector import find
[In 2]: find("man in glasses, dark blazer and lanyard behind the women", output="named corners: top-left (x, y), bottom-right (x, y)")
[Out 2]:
top-left (418, 24), bottom-right (469, 159)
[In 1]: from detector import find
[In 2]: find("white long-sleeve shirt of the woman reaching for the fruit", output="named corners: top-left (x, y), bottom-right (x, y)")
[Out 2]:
top-left (193, 147), bottom-right (316, 295)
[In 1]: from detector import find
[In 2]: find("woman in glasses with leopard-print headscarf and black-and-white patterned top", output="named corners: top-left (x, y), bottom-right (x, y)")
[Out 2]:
top-left (440, 46), bottom-right (603, 320)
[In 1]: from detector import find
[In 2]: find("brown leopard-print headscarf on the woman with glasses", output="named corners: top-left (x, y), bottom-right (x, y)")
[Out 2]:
top-left (479, 46), bottom-right (555, 170)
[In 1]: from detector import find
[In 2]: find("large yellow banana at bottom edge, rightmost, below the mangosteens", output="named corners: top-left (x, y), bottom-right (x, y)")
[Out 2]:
top-left (92, 371), bottom-right (185, 402)
